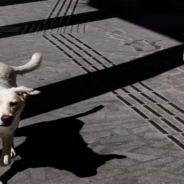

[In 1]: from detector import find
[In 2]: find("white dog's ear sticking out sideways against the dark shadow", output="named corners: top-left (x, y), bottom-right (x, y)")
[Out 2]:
top-left (11, 86), bottom-right (41, 100)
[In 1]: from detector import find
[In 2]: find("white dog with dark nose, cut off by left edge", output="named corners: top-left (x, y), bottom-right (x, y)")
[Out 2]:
top-left (0, 53), bottom-right (42, 166)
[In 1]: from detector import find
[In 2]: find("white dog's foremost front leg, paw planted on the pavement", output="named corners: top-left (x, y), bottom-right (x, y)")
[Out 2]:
top-left (0, 134), bottom-right (13, 166)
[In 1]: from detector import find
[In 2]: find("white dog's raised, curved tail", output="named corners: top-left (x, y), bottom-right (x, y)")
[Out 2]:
top-left (11, 53), bottom-right (42, 75)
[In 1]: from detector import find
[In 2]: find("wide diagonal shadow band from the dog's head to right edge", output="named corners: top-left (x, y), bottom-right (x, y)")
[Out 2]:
top-left (21, 45), bottom-right (183, 120)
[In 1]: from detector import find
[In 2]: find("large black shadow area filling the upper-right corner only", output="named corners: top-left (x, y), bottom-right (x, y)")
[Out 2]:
top-left (89, 0), bottom-right (184, 41)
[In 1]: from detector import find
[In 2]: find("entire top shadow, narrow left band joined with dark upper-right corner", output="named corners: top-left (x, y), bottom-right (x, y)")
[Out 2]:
top-left (0, 0), bottom-right (184, 41)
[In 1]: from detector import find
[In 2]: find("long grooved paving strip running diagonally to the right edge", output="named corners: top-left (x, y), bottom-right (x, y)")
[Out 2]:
top-left (43, 34), bottom-right (184, 149)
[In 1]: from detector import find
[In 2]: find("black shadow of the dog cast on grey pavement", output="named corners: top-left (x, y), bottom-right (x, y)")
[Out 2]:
top-left (1, 106), bottom-right (125, 183)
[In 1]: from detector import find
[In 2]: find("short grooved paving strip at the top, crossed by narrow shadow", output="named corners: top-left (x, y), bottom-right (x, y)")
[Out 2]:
top-left (20, 0), bottom-right (79, 35)
